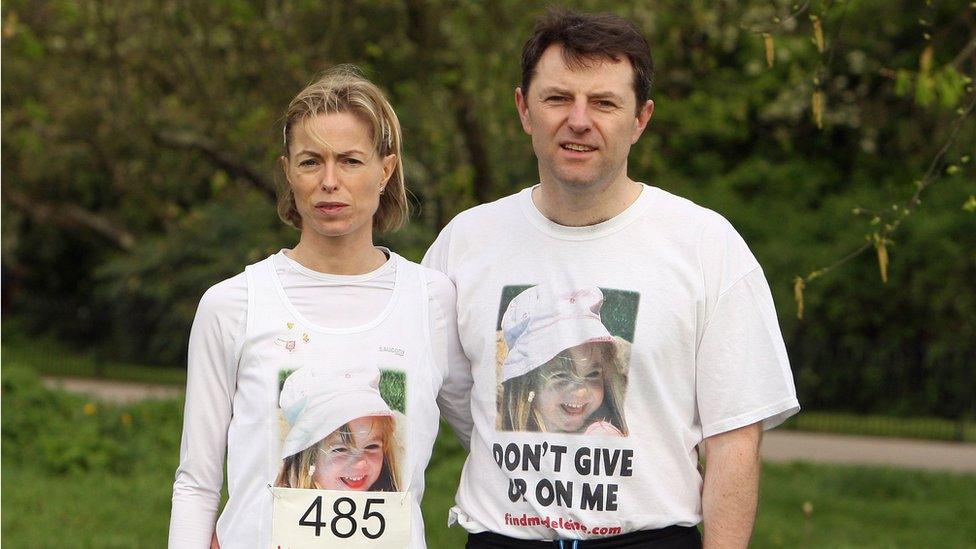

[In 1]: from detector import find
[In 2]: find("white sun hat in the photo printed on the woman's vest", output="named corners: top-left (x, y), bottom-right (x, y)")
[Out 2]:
top-left (278, 366), bottom-right (393, 459)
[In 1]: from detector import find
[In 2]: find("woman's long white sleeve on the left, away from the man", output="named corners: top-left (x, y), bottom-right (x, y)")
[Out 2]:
top-left (169, 274), bottom-right (247, 548)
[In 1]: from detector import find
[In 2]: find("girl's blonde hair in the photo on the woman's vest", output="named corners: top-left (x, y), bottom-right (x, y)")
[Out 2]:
top-left (275, 416), bottom-right (400, 492)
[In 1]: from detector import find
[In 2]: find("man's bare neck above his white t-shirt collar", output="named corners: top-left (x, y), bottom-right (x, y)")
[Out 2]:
top-left (532, 177), bottom-right (641, 227)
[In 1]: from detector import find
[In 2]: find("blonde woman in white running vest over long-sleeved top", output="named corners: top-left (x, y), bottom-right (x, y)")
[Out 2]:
top-left (169, 66), bottom-right (471, 548)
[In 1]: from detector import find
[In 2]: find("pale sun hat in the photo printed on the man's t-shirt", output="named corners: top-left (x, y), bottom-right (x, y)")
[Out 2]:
top-left (502, 284), bottom-right (613, 382)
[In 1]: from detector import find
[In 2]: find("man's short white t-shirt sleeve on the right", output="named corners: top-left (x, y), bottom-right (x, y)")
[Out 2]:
top-left (696, 214), bottom-right (800, 437)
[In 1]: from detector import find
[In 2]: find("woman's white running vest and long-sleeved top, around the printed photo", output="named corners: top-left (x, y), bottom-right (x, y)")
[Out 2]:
top-left (169, 250), bottom-right (471, 548)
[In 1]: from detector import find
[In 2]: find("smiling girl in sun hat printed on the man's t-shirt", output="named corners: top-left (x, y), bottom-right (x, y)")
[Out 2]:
top-left (498, 285), bottom-right (630, 436)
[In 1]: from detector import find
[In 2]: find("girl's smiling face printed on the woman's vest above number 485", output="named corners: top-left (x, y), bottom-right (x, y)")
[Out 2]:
top-left (312, 417), bottom-right (385, 491)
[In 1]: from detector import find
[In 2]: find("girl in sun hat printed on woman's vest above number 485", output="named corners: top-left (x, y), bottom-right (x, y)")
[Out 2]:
top-left (275, 367), bottom-right (402, 492)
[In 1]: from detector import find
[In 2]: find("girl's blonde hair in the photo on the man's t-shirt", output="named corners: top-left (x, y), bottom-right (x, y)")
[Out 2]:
top-left (497, 337), bottom-right (630, 436)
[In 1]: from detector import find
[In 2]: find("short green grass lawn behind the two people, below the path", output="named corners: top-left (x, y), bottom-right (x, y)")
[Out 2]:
top-left (2, 414), bottom-right (976, 548)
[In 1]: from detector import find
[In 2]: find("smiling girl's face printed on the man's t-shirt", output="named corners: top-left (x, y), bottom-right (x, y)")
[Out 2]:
top-left (535, 343), bottom-right (607, 433)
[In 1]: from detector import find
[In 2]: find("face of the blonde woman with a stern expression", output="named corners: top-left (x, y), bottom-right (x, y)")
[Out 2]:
top-left (282, 112), bottom-right (396, 245)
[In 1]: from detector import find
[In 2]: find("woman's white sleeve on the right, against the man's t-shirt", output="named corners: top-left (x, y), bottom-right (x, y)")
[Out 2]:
top-left (428, 262), bottom-right (474, 449)
